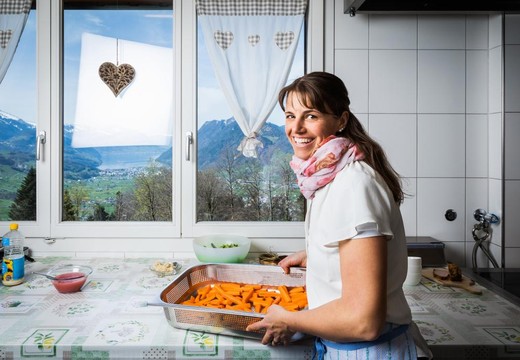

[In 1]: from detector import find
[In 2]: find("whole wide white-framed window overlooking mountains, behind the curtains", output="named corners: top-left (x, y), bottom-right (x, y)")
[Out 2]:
top-left (0, 0), bottom-right (323, 245)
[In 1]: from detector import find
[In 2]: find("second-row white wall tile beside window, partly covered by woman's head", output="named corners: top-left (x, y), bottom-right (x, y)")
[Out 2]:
top-left (334, 50), bottom-right (368, 113)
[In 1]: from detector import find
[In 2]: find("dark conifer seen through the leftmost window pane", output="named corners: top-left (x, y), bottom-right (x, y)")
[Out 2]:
top-left (9, 167), bottom-right (36, 221)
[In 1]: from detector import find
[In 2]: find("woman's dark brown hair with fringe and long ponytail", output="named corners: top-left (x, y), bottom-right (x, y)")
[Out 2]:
top-left (278, 72), bottom-right (404, 203)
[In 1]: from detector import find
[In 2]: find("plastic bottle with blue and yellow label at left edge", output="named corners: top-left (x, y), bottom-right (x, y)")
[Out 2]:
top-left (2, 223), bottom-right (25, 286)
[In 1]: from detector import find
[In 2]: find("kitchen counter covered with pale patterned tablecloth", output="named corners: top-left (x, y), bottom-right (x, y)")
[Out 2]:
top-left (0, 257), bottom-right (520, 360)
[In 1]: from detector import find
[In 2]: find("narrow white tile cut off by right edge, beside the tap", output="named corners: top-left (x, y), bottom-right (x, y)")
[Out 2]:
top-left (504, 180), bottom-right (520, 250)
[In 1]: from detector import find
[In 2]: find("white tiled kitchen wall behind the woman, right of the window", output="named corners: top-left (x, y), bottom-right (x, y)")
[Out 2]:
top-left (325, 0), bottom-right (520, 267)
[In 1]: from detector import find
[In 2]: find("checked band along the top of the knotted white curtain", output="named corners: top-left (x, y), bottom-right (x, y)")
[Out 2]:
top-left (197, 0), bottom-right (307, 16)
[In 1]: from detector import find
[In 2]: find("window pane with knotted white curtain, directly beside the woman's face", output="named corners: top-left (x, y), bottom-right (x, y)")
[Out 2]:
top-left (197, 0), bottom-right (305, 222)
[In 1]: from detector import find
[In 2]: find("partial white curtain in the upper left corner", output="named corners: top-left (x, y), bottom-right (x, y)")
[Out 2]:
top-left (0, 0), bottom-right (32, 83)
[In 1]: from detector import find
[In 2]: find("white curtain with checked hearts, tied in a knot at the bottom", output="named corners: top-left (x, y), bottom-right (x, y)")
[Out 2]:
top-left (197, 0), bottom-right (307, 157)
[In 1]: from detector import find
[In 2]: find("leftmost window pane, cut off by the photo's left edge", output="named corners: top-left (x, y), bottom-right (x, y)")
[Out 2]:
top-left (0, 4), bottom-right (37, 221)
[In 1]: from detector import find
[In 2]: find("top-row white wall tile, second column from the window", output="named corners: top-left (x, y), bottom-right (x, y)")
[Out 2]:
top-left (368, 14), bottom-right (417, 49)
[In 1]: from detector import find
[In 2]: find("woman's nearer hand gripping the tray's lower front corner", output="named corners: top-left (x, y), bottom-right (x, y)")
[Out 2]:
top-left (246, 305), bottom-right (294, 346)
